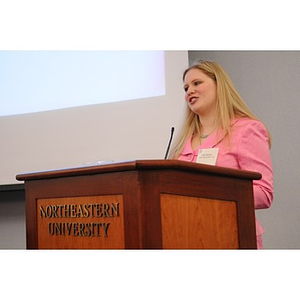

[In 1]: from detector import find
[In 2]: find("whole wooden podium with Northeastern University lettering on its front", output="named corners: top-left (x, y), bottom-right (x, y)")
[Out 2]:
top-left (16, 160), bottom-right (261, 249)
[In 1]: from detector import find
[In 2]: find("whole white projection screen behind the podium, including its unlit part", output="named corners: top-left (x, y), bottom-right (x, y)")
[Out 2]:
top-left (0, 51), bottom-right (188, 184)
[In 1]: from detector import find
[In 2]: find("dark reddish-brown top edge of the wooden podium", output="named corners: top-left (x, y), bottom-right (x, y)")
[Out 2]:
top-left (16, 159), bottom-right (261, 181)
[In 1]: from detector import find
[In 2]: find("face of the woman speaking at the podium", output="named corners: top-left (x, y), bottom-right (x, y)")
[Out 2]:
top-left (183, 69), bottom-right (217, 117)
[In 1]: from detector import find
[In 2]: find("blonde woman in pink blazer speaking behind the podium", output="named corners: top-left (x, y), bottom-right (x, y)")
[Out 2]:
top-left (171, 61), bottom-right (273, 249)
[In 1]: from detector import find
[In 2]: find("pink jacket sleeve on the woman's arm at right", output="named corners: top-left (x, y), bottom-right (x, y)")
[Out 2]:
top-left (238, 121), bottom-right (273, 209)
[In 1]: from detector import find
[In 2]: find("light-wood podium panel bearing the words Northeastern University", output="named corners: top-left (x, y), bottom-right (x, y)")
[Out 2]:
top-left (36, 195), bottom-right (125, 249)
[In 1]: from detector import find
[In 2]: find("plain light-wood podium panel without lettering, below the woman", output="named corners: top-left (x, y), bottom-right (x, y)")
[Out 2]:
top-left (161, 194), bottom-right (239, 249)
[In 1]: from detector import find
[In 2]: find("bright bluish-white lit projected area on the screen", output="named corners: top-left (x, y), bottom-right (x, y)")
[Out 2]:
top-left (0, 51), bottom-right (165, 116)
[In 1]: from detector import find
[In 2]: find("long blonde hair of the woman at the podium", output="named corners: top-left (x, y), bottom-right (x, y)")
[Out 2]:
top-left (170, 60), bottom-right (271, 158)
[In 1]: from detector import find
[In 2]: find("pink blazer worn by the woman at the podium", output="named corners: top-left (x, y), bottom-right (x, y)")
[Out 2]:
top-left (178, 118), bottom-right (273, 246)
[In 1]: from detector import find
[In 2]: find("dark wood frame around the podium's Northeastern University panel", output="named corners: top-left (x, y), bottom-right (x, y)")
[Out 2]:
top-left (26, 171), bottom-right (142, 249)
